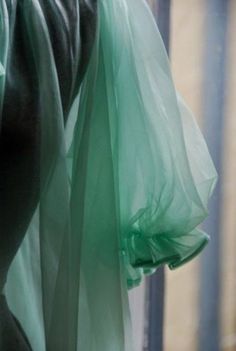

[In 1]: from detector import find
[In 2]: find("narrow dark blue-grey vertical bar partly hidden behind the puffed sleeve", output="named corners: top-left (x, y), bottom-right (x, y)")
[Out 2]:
top-left (148, 0), bottom-right (171, 351)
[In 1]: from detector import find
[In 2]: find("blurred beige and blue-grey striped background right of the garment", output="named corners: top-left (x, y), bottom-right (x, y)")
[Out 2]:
top-left (130, 0), bottom-right (236, 351)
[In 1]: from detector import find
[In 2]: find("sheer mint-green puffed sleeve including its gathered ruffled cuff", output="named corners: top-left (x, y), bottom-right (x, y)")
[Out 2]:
top-left (76, 0), bottom-right (216, 287)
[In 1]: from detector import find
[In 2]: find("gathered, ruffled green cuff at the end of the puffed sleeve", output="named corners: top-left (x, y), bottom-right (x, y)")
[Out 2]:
top-left (125, 229), bottom-right (210, 288)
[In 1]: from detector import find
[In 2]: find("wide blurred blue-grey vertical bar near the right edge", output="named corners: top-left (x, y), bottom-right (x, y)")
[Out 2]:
top-left (199, 0), bottom-right (228, 351)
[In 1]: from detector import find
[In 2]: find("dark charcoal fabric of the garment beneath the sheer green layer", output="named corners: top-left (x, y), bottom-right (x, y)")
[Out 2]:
top-left (0, 0), bottom-right (97, 351)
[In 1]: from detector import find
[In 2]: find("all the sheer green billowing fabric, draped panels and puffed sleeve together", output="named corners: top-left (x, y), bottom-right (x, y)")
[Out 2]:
top-left (0, 0), bottom-right (216, 351)
